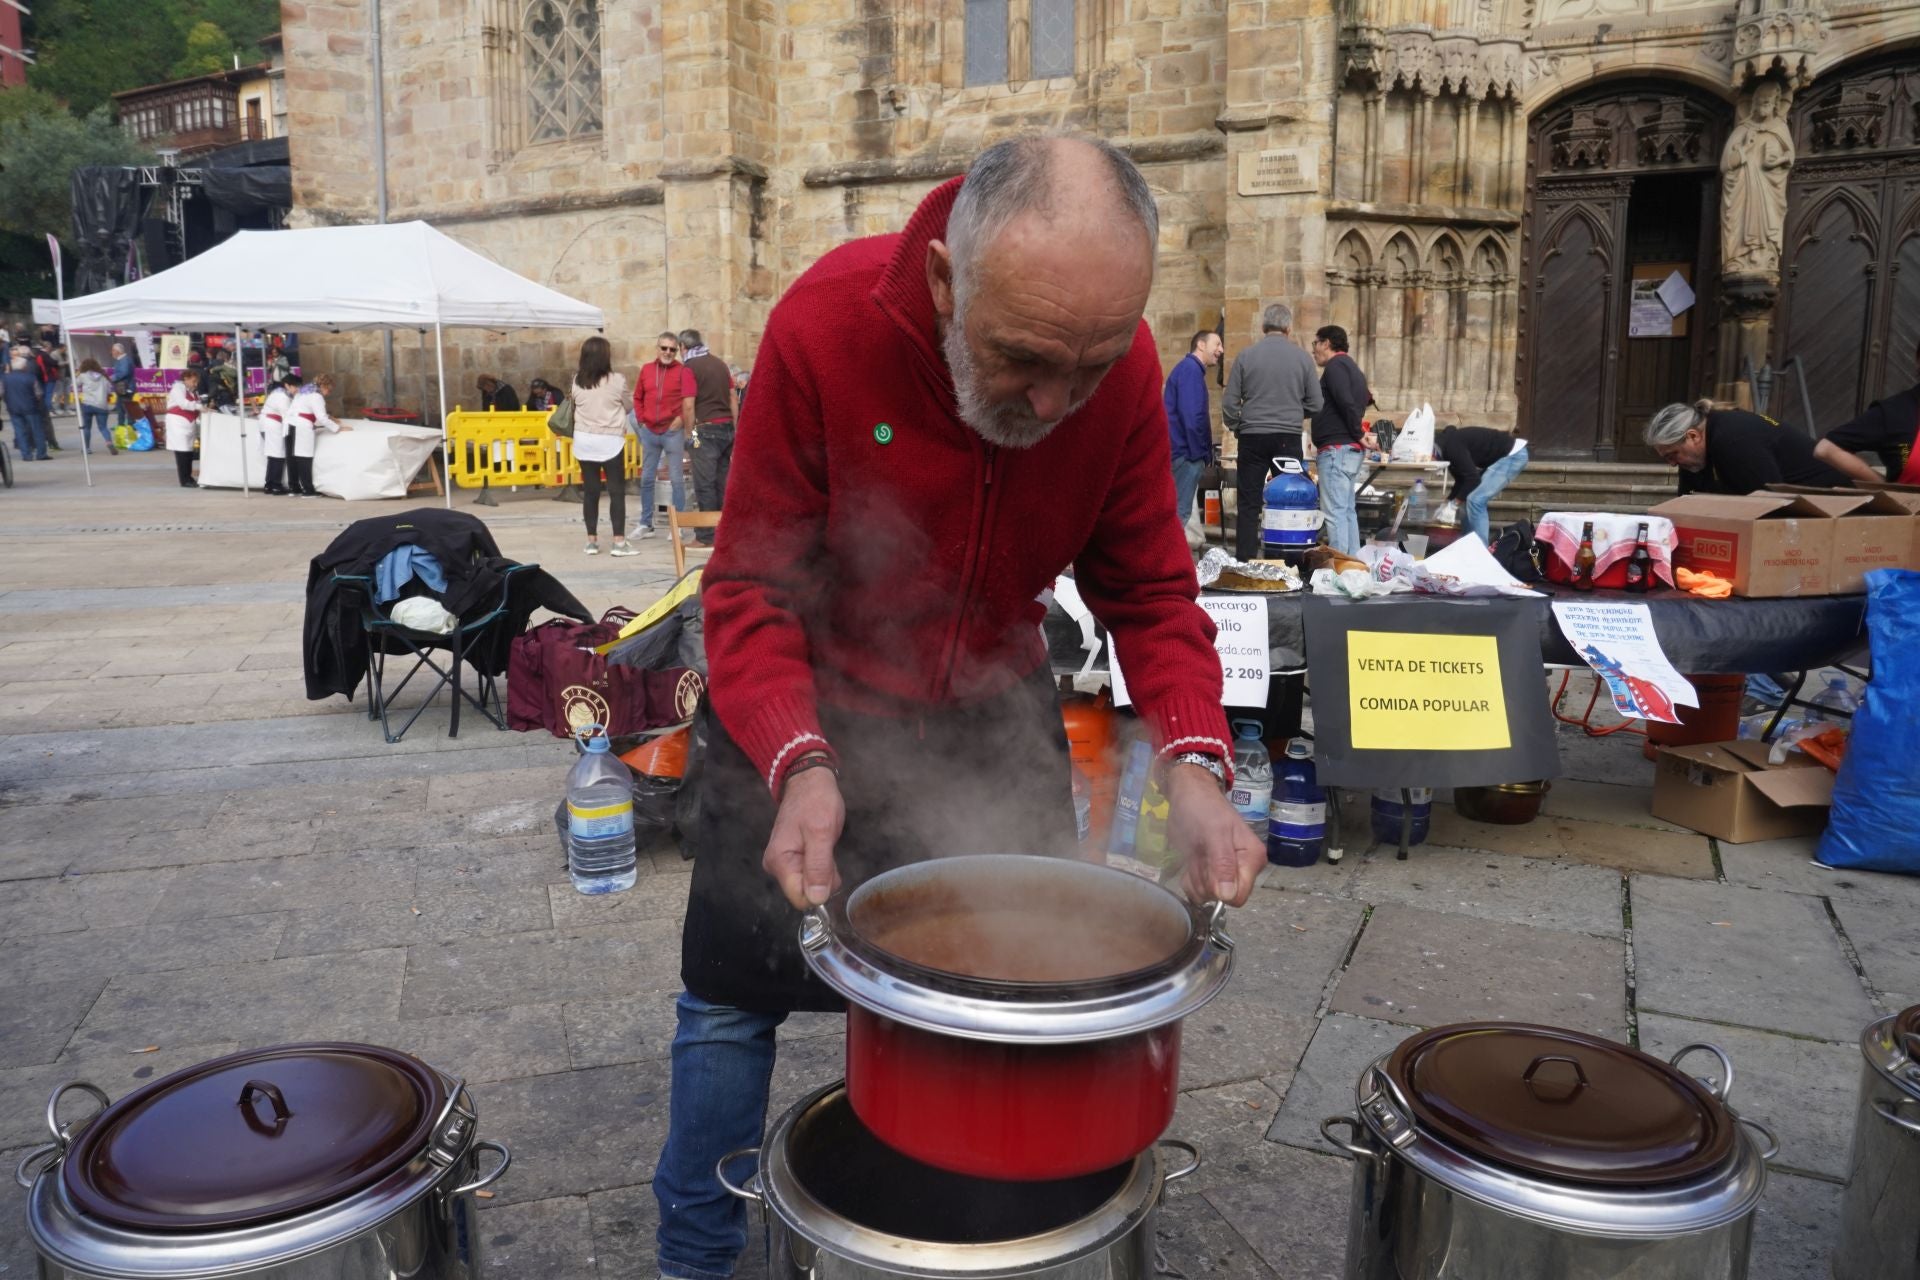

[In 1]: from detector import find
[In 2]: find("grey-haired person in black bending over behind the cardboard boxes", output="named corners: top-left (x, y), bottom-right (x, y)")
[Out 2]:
top-left (1645, 399), bottom-right (1853, 493)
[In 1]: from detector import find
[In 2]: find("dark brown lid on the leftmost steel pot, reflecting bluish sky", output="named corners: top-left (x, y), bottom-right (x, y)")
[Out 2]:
top-left (61, 1044), bottom-right (447, 1232)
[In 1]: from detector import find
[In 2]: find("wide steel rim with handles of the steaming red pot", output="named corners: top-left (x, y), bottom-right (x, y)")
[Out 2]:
top-left (801, 854), bottom-right (1233, 1044)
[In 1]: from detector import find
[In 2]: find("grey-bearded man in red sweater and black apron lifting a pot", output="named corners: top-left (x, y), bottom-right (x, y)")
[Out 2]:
top-left (653, 138), bottom-right (1265, 1280)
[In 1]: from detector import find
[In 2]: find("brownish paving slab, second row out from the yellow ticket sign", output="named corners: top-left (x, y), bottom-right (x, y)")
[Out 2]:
top-left (1331, 906), bottom-right (1626, 1040)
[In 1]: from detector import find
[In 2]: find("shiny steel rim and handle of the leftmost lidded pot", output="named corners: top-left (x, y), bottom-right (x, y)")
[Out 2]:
top-left (27, 1071), bottom-right (513, 1280)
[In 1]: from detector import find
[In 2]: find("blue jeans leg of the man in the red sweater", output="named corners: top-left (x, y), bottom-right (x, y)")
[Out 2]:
top-left (649, 990), bottom-right (787, 1280)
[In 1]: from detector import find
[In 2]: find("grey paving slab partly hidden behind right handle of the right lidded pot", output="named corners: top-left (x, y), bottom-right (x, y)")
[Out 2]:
top-left (1640, 1013), bottom-right (1860, 1178)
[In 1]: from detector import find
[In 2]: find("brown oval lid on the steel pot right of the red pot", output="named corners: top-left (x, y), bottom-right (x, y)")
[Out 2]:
top-left (1386, 1023), bottom-right (1736, 1186)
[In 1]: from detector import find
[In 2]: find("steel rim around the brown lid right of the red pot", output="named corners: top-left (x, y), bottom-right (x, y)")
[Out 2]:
top-left (1329, 1054), bottom-right (1766, 1240)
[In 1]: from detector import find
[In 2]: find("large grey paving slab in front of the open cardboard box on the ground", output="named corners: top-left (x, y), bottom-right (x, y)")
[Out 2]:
top-left (1632, 875), bottom-right (1876, 1042)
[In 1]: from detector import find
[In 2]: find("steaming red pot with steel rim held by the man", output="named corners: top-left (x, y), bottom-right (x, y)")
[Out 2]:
top-left (801, 854), bottom-right (1233, 1180)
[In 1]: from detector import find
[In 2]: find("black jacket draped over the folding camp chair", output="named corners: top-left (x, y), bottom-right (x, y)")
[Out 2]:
top-left (301, 507), bottom-right (591, 700)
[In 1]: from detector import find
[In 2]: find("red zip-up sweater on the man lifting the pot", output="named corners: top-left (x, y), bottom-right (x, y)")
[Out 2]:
top-left (703, 178), bottom-right (1231, 793)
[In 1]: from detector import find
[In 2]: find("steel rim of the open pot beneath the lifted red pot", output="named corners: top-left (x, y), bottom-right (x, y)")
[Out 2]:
top-left (753, 1080), bottom-right (1167, 1280)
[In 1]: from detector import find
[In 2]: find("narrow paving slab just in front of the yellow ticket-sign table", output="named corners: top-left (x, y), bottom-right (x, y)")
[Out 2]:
top-left (1352, 848), bottom-right (1624, 938)
